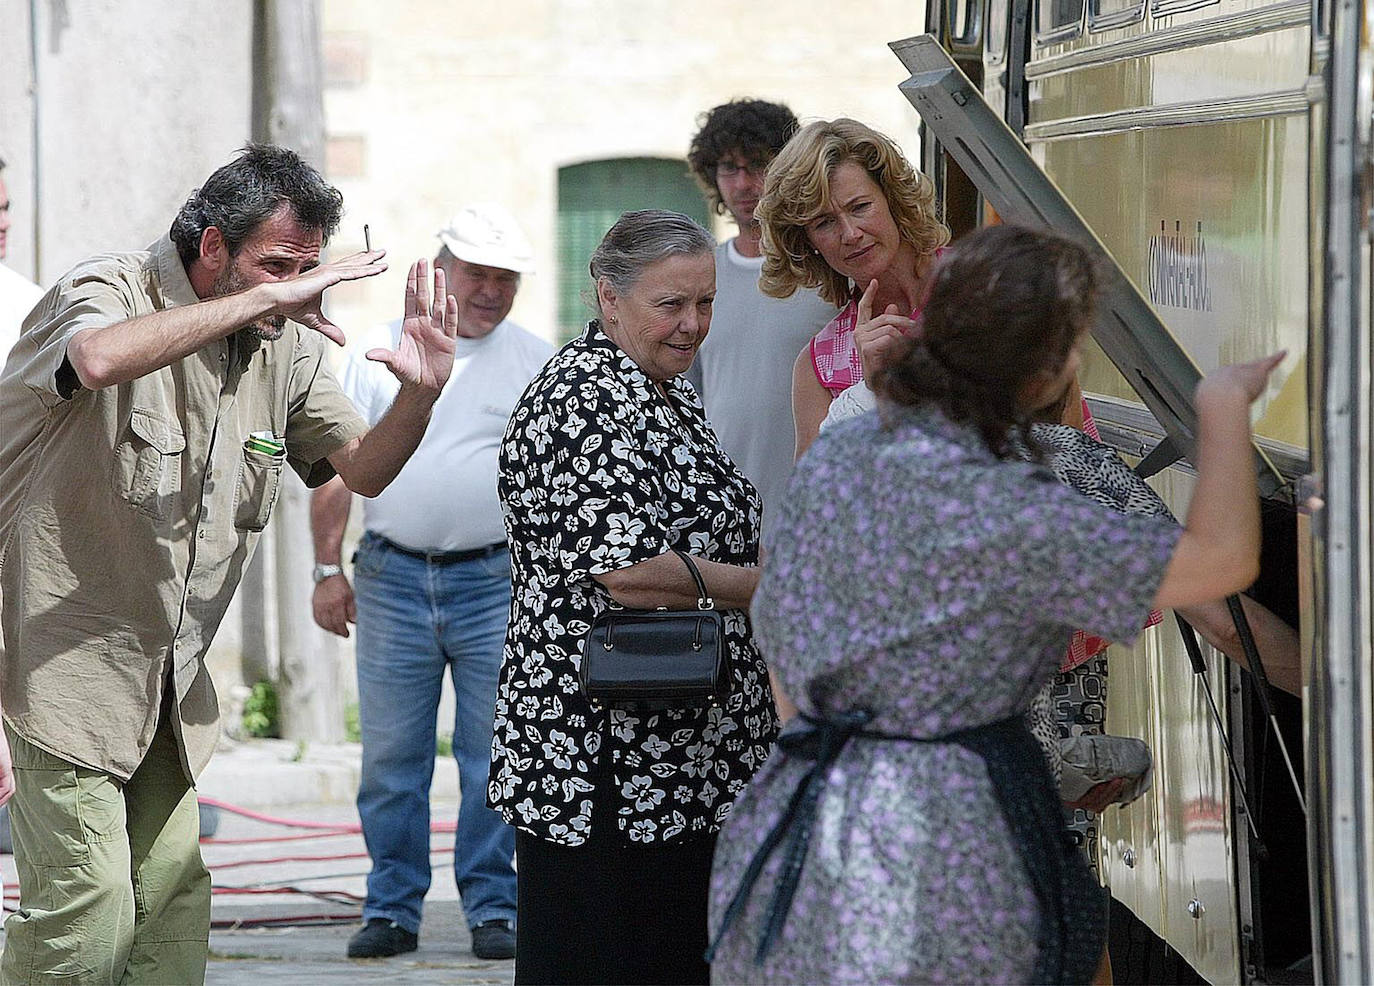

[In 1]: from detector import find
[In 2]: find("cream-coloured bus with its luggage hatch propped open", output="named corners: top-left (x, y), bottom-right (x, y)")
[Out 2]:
top-left (892, 0), bottom-right (1374, 983)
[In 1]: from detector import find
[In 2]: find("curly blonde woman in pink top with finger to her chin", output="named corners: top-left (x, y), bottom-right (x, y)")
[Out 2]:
top-left (756, 118), bottom-right (949, 459)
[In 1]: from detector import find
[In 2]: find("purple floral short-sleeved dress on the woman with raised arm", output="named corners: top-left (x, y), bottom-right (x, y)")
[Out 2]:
top-left (710, 409), bottom-right (1179, 983)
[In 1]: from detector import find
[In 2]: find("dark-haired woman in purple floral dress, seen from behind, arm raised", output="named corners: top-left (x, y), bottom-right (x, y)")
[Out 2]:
top-left (712, 227), bottom-right (1276, 983)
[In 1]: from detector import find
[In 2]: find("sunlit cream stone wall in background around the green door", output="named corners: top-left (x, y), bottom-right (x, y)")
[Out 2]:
top-left (323, 0), bottom-right (925, 343)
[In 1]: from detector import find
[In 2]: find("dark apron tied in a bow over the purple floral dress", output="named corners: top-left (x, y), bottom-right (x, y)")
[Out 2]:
top-left (706, 711), bottom-right (1107, 983)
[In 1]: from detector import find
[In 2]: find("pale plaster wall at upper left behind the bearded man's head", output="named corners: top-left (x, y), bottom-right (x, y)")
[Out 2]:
top-left (0, 0), bottom-right (253, 284)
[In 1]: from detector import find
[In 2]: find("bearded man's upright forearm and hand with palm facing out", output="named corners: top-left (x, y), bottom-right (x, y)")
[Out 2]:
top-left (328, 260), bottom-right (458, 497)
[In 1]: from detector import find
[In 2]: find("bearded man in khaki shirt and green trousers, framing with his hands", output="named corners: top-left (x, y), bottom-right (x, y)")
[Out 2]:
top-left (0, 144), bottom-right (458, 983)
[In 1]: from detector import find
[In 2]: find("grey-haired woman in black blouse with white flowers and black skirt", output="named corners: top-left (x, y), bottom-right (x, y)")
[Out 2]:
top-left (489, 211), bottom-right (776, 983)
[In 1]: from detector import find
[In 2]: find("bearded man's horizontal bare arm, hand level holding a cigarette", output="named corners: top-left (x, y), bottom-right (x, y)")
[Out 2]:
top-left (67, 250), bottom-right (386, 390)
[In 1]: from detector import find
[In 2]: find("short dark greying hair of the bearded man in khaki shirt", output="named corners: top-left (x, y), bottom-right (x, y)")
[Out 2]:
top-left (169, 143), bottom-right (344, 266)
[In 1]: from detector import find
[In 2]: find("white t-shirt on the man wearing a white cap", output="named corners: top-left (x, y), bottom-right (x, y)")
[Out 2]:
top-left (341, 319), bottom-right (554, 551)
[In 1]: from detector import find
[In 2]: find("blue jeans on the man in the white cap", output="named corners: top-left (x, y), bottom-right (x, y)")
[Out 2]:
top-left (353, 533), bottom-right (515, 932)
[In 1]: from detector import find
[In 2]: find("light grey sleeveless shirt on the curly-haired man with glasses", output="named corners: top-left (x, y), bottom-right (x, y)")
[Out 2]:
top-left (686, 240), bottom-right (835, 518)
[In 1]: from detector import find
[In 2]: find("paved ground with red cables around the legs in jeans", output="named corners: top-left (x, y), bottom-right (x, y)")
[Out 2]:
top-left (0, 742), bottom-right (514, 986)
